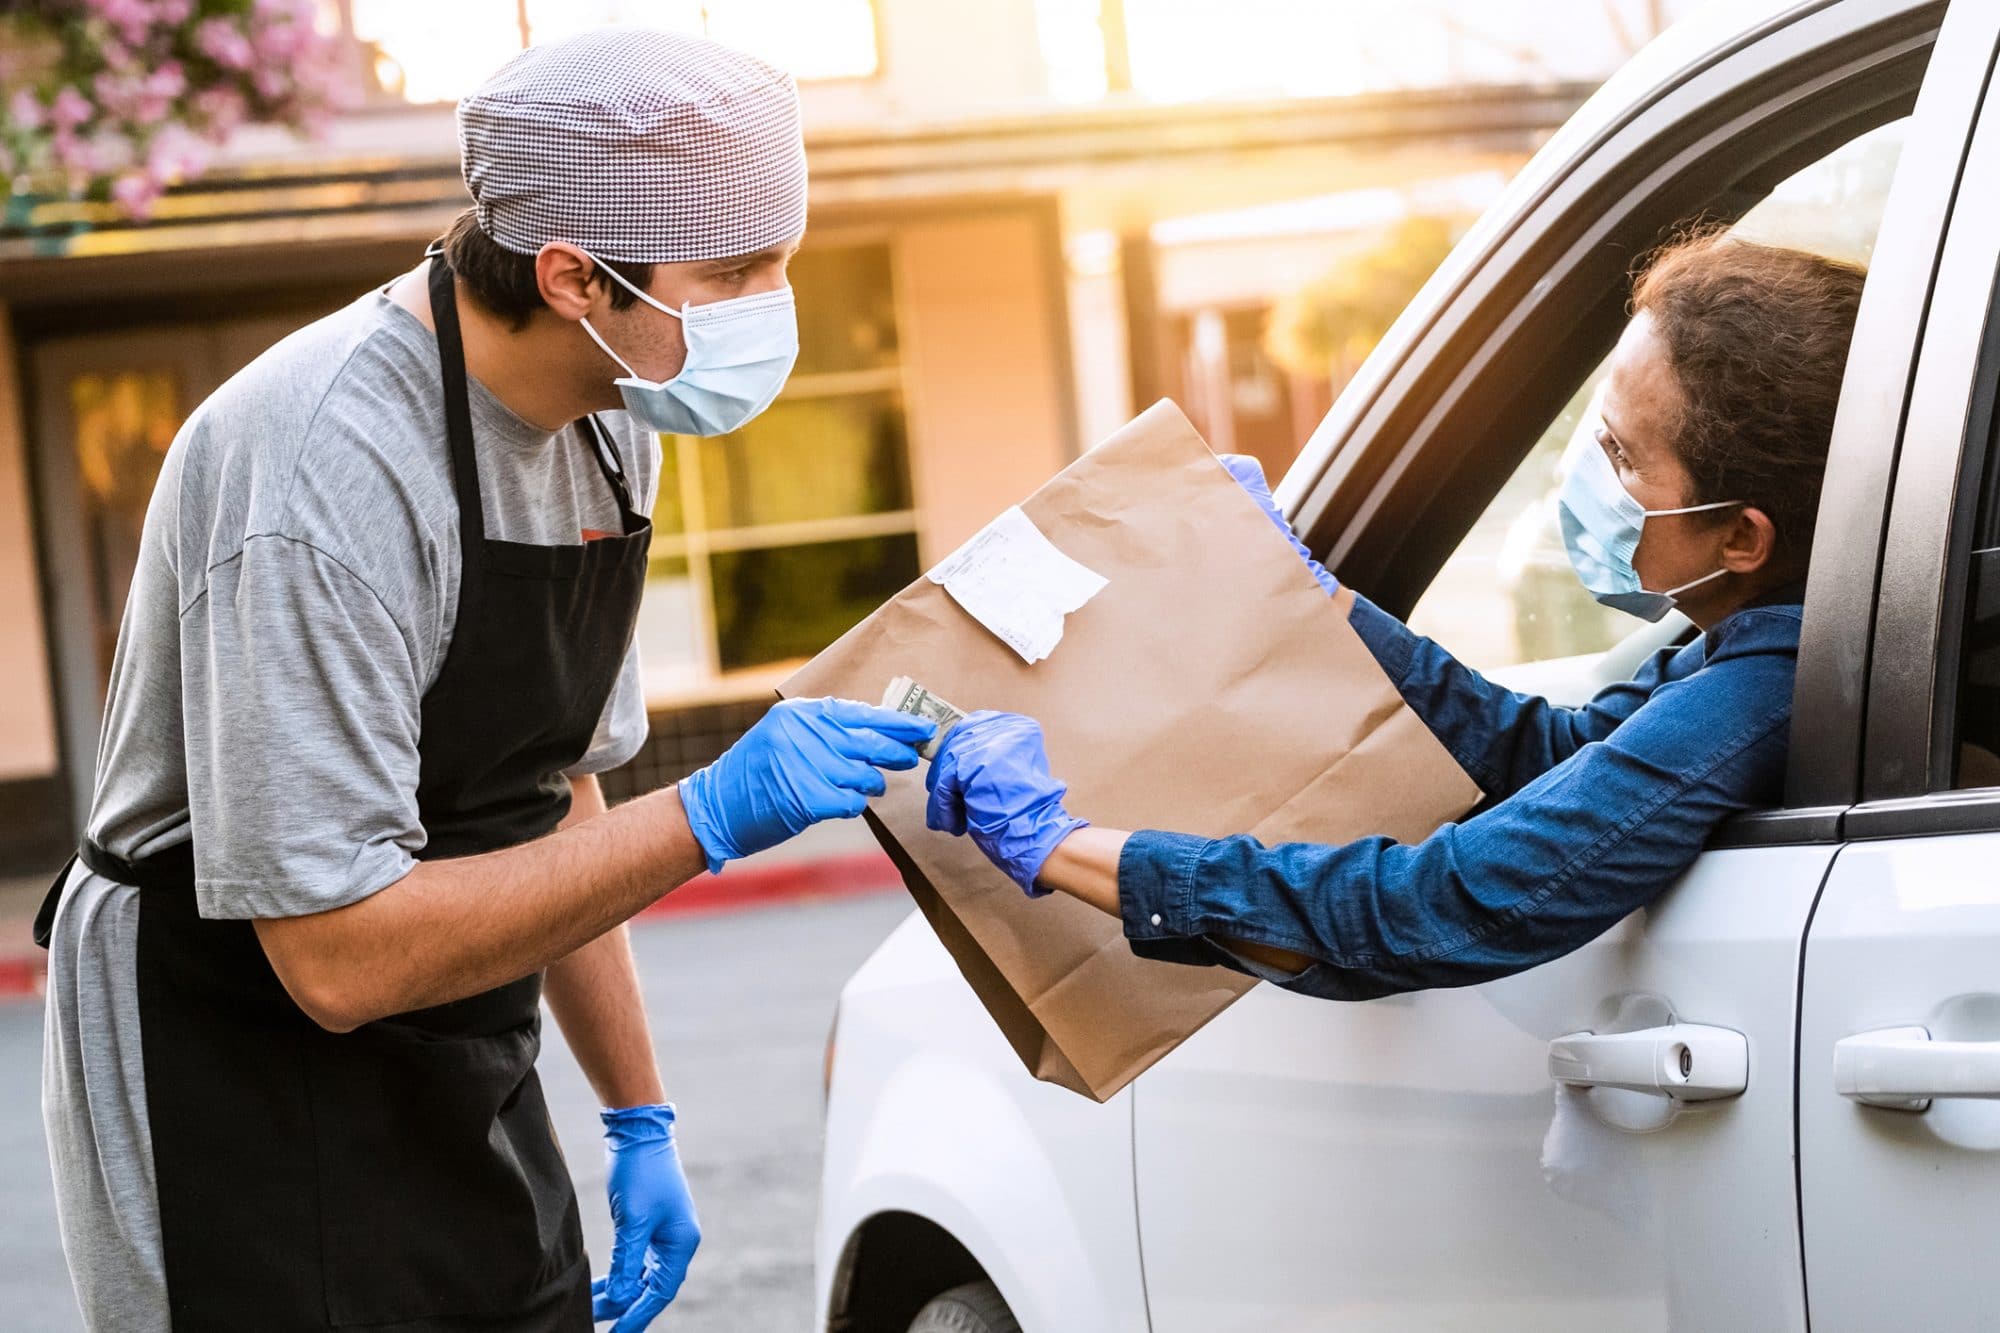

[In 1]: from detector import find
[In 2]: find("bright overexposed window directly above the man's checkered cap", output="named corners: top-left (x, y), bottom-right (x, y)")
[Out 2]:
top-left (344, 0), bottom-right (880, 102)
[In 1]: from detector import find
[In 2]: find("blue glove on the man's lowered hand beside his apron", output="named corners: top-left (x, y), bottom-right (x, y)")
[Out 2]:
top-left (590, 1105), bottom-right (702, 1333)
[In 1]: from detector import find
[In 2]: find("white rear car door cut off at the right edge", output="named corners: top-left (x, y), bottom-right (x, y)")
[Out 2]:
top-left (1798, 4), bottom-right (2000, 1333)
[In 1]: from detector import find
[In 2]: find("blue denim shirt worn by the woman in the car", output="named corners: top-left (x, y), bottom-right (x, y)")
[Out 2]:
top-left (1118, 586), bottom-right (1802, 999)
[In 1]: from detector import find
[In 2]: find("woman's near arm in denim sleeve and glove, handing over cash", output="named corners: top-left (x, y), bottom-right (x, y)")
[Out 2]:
top-left (932, 620), bottom-right (1796, 999)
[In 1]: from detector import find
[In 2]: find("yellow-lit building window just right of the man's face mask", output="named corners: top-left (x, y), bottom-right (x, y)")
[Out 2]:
top-left (638, 244), bottom-right (922, 705)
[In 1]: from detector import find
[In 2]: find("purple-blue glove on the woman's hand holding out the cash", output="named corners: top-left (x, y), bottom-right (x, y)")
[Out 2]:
top-left (924, 711), bottom-right (1090, 899)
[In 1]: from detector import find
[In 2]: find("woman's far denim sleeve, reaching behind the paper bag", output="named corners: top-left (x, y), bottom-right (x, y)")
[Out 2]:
top-left (1348, 594), bottom-right (1680, 799)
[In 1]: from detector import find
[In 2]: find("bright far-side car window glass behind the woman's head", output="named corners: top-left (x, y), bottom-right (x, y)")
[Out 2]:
top-left (1410, 120), bottom-right (1904, 668)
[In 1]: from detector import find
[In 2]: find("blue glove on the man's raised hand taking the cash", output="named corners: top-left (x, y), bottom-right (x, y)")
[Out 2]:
top-left (680, 699), bottom-right (936, 871)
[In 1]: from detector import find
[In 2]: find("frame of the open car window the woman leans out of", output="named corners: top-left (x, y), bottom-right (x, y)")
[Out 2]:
top-left (1280, 0), bottom-right (1960, 843)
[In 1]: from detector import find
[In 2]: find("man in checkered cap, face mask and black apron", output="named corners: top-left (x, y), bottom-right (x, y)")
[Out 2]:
top-left (38, 32), bottom-right (930, 1333)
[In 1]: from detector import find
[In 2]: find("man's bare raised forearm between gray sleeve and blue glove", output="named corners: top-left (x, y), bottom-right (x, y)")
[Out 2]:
top-left (256, 789), bottom-right (706, 1031)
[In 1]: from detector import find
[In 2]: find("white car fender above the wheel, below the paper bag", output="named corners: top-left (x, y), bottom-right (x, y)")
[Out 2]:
top-left (816, 915), bottom-right (1146, 1333)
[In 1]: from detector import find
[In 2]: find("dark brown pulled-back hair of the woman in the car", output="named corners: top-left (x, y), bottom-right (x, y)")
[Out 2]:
top-left (1632, 226), bottom-right (1866, 568)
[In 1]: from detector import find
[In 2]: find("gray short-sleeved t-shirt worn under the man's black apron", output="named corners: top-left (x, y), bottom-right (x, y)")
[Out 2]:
top-left (90, 292), bottom-right (660, 917)
